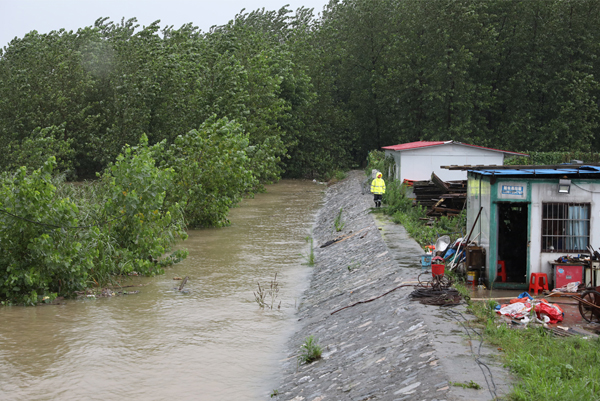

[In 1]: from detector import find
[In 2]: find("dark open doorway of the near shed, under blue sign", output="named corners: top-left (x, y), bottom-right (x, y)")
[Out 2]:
top-left (498, 202), bottom-right (529, 283)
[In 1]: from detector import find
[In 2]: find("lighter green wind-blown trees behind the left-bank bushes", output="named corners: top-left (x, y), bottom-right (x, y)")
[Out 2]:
top-left (0, 8), bottom-right (345, 182)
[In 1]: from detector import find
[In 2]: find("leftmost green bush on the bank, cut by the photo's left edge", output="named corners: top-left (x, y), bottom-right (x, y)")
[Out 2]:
top-left (0, 157), bottom-right (91, 304)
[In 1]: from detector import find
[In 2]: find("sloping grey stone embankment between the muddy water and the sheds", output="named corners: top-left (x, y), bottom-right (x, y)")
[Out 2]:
top-left (275, 171), bottom-right (506, 401)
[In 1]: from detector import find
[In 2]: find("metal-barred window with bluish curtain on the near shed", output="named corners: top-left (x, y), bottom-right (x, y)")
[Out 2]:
top-left (542, 203), bottom-right (590, 252)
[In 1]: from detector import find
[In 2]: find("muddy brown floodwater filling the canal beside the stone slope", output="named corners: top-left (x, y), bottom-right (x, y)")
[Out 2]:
top-left (0, 180), bottom-right (324, 401)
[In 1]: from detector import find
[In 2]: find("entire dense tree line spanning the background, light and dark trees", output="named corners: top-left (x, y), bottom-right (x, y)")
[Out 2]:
top-left (0, 0), bottom-right (600, 181)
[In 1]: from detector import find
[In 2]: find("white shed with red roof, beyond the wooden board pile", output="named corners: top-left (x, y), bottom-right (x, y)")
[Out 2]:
top-left (382, 141), bottom-right (527, 181)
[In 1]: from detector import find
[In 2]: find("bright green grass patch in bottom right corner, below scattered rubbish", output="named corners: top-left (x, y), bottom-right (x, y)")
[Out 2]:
top-left (469, 301), bottom-right (600, 401)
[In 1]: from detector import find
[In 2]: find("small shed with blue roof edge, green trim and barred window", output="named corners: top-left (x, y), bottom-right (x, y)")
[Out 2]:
top-left (444, 164), bottom-right (600, 289)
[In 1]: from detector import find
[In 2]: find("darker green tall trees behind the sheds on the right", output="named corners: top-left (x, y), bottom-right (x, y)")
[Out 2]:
top-left (322, 0), bottom-right (600, 154)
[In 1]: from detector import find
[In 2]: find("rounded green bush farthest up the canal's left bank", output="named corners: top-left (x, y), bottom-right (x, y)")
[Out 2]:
top-left (154, 116), bottom-right (258, 227)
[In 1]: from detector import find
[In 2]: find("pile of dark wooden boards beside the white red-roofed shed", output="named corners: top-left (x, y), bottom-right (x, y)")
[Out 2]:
top-left (413, 173), bottom-right (467, 217)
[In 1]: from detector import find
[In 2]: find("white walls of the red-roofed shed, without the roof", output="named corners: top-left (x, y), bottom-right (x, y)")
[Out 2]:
top-left (386, 143), bottom-right (504, 181)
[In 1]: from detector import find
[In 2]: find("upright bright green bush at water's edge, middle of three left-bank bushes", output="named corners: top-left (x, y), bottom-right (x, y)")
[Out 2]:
top-left (101, 135), bottom-right (187, 275)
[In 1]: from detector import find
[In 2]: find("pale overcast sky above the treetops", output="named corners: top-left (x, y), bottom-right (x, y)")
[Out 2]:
top-left (0, 0), bottom-right (329, 47)
